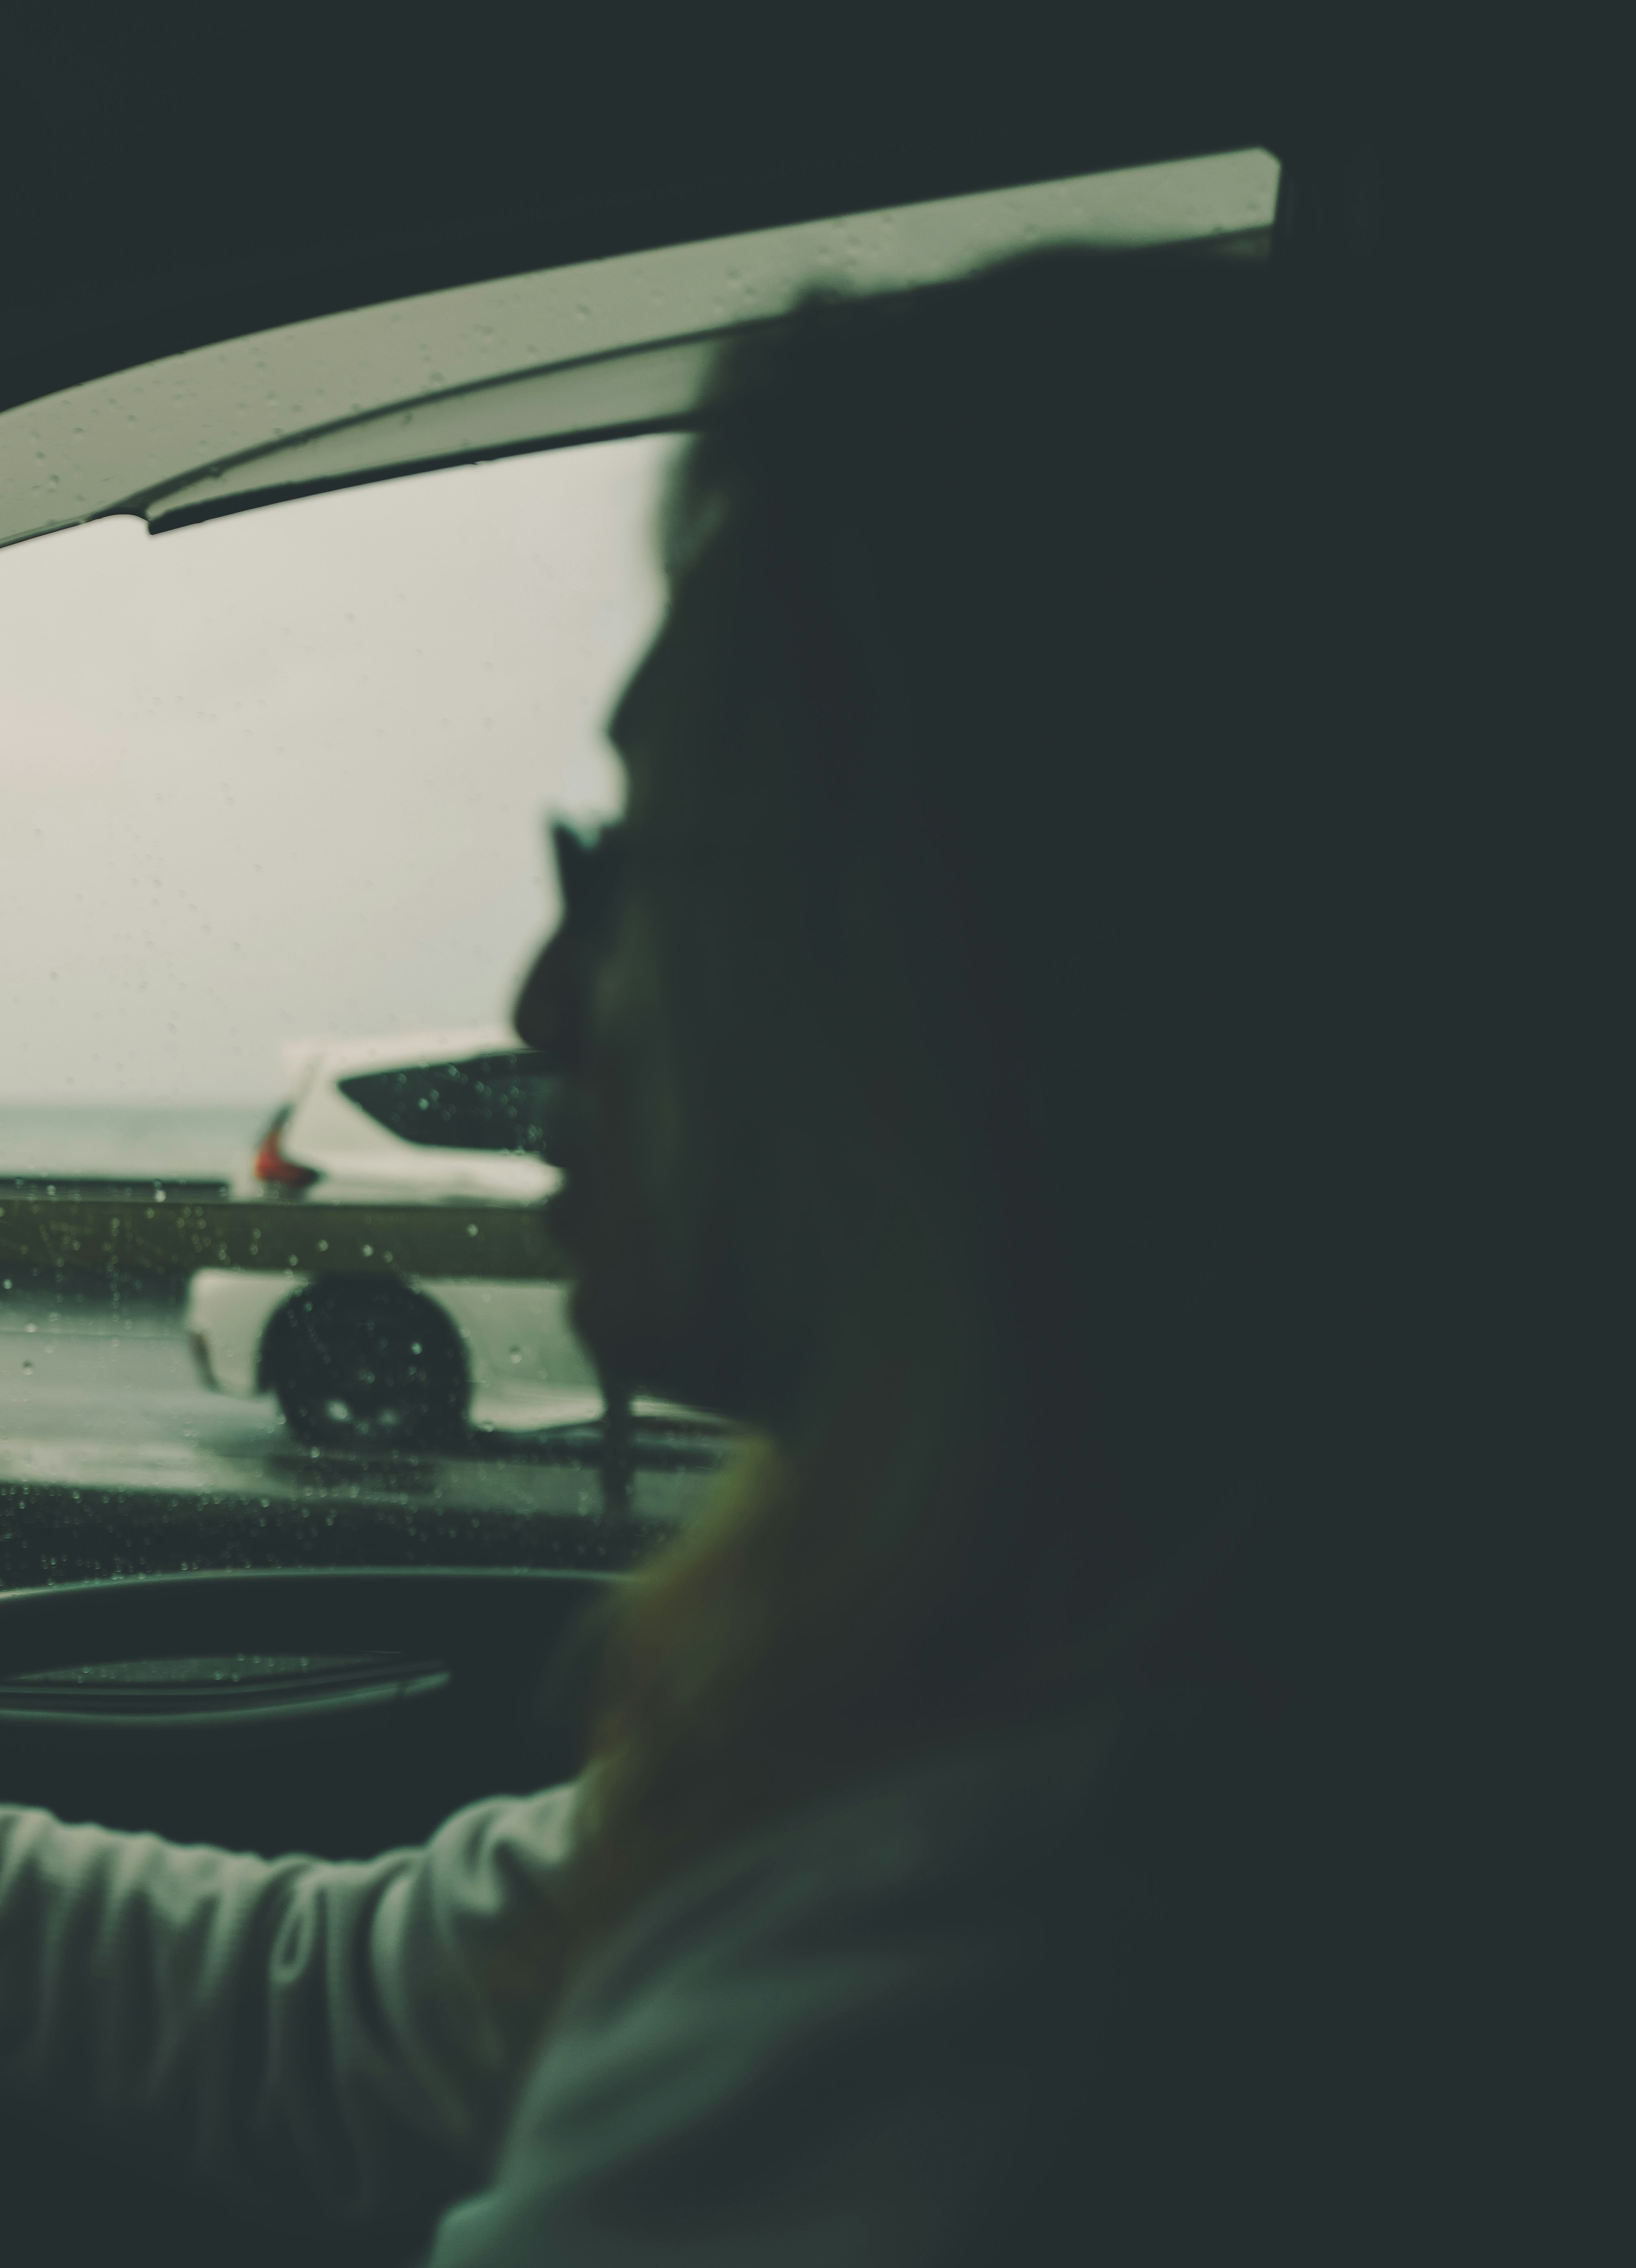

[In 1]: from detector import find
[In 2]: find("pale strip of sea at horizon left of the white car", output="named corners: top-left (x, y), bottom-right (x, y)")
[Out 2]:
top-left (0, 1102), bottom-right (272, 1182)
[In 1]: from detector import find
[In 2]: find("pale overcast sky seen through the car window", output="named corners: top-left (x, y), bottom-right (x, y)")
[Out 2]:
top-left (0, 438), bottom-right (674, 1102)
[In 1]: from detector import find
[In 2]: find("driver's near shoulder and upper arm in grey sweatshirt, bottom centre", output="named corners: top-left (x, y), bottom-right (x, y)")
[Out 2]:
top-left (436, 1701), bottom-right (1279, 2263)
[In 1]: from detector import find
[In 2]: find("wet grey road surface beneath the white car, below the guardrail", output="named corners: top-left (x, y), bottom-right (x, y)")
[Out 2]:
top-left (0, 1284), bottom-right (721, 1517)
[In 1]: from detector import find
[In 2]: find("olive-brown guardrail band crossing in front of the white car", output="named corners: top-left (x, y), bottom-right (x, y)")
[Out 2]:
top-left (0, 1191), bottom-right (570, 1281)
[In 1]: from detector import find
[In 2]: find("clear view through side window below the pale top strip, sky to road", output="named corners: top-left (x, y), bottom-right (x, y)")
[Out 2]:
top-left (0, 438), bottom-right (719, 1583)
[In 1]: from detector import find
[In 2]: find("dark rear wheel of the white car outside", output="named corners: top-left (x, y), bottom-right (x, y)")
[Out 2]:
top-left (263, 1279), bottom-right (469, 1449)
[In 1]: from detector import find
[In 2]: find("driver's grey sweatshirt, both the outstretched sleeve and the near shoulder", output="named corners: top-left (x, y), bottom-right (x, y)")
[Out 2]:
top-left (0, 1712), bottom-right (1198, 2268)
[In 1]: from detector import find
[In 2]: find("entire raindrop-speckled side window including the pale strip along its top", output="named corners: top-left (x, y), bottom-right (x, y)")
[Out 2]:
top-left (0, 152), bottom-right (1278, 1583)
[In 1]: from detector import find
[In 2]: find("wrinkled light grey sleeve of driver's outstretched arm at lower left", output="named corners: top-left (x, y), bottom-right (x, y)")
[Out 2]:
top-left (0, 1785), bottom-right (576, 2220)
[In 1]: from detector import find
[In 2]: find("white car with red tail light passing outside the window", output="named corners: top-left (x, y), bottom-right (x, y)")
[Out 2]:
top-left (186, 1030), bottom-right (604, 1447)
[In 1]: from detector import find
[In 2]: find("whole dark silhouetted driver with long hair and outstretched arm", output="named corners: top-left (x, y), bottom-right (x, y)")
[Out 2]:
top-left (0, 252), bottom-right (1606, 2268)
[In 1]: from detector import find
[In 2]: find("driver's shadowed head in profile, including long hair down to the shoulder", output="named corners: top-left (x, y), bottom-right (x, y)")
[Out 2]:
top-left (517, 252), bottom-right (1470, 2005)
